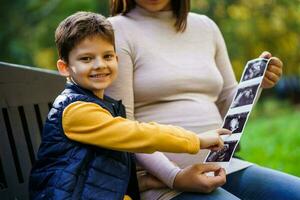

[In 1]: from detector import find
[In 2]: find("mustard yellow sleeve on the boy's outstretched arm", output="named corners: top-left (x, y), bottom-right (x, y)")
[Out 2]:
top-left (62, 101), bottom-right (200, 153)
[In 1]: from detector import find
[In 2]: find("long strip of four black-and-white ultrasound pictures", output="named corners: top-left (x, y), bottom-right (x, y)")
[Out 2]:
top-left (204, 58), bottom-right (271, 167)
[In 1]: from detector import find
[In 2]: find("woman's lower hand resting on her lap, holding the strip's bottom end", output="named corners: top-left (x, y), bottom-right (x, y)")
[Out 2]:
top-left (173, 164), bottom-right (226, 193)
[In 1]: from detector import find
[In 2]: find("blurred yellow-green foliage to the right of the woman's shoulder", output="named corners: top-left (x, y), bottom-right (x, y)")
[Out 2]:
top-left (192, 0), bottom-right (300, 77)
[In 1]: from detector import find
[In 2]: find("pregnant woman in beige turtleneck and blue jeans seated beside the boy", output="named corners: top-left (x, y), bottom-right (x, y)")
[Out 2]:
top-left (108, 0), bottom-right (300, 200)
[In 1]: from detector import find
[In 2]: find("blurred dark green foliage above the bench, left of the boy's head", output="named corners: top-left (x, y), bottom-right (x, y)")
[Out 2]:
top-left (0, 0), bottom-right (109, 69)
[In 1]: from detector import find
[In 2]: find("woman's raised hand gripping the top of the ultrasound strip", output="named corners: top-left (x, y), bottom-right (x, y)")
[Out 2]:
top-left (259, 51), bottom-right (283, 89)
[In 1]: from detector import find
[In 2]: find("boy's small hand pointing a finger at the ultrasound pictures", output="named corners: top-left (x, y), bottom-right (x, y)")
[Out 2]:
top-left (198, 128), bottom-right (232, 150)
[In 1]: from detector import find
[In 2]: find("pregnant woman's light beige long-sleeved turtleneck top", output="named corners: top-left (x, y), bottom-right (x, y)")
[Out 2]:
top-left (107, 7), bottom-right (249, 199)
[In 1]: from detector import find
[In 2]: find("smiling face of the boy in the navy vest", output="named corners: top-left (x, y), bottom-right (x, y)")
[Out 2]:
top-left (58, 36), bottom-right (118, 98)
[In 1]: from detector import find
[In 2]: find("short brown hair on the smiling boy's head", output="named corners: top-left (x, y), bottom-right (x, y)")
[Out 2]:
top-left (55, 12), bottom-right (115, 62)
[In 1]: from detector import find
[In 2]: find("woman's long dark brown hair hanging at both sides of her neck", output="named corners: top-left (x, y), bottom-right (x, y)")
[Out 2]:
top-left (110, 0), bottom-right (191, 32)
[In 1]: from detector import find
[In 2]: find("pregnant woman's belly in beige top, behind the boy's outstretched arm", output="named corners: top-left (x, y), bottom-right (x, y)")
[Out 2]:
top-left (135, 99), bottom-right (222, 167)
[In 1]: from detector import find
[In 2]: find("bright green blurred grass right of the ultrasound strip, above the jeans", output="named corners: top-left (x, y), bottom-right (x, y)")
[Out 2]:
top-left (237, 99), bottom-right (300, 176)
